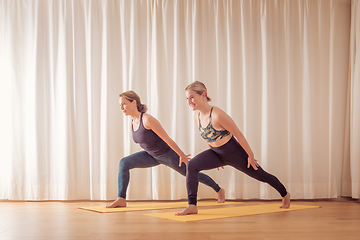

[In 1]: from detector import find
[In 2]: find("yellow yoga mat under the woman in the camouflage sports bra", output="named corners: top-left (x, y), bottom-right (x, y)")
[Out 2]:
top-left (145, 203), bottom-right (319, 222)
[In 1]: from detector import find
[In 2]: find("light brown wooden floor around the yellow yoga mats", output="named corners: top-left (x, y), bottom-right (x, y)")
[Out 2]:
top-left (0, 200), bottom-right (360, 240)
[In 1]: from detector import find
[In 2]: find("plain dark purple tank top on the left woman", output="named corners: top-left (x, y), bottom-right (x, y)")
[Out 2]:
top-left (131, 113), bottom-right (170, 157)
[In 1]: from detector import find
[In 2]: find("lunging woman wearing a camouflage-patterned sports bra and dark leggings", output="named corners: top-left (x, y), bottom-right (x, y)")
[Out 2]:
top-left (176, 81), bottom-right (290, 215)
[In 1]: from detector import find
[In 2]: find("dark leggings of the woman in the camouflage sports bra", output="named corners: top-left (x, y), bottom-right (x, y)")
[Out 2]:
top-left (186, 137), bottom-right (287, 205)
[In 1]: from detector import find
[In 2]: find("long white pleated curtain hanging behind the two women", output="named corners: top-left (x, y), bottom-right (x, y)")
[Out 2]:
top-left (0, 0), bottom-right (360, 200)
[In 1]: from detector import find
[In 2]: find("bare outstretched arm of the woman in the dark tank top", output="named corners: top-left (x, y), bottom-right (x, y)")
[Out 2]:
top-left (143, 114), bottom-right (190, 166)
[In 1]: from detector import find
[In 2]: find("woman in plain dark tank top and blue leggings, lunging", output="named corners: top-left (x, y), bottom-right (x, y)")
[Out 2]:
top-left (106, 91), bottom-right (225, 208)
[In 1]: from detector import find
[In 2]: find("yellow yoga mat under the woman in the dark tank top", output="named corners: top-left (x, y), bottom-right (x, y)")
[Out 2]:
top-left (79, 200), bottom-right (242, 213)
